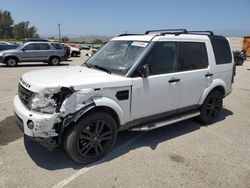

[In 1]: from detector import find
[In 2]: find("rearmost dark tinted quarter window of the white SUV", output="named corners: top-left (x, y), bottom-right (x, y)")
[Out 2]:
top-left (209, 35), bottom-right (232, 64)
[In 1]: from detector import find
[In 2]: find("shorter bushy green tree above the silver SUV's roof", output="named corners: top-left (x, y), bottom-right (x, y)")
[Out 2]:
top-left (13, 22), bottom-right (39, 40)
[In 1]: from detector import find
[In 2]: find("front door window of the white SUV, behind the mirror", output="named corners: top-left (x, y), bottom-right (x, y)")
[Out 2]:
top-left (144, 42), bottom-right (177, 75)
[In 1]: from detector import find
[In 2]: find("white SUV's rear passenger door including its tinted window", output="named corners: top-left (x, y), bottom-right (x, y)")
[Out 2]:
top-left (176, 42), bottom-right (213, 109)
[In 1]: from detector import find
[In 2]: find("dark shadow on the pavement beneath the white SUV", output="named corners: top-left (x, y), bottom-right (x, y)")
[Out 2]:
top-left (24, 108), bottom-right (233, 170)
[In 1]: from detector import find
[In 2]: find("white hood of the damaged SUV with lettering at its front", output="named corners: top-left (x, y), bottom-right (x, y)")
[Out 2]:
top-left (20, 66), bottom-right (132, 93)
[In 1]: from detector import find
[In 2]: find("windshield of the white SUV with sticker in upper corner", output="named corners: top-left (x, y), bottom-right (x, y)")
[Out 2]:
top-left (83, 41), bottom-right (148, 75)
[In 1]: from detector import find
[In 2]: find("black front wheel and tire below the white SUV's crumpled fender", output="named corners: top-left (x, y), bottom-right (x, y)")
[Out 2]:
top-left (64, 112), bottom-right (117, 164)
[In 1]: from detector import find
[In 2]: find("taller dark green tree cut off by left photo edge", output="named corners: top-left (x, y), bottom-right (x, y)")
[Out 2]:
top-left (0, 10), bottom-right (14, 38)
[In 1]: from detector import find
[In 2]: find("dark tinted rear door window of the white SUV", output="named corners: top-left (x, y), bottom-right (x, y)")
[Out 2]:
top-left (177, 42), bottom-right (208, 71)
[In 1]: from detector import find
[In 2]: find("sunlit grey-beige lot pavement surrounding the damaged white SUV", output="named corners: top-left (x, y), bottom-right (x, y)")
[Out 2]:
top-left (0, 46), bottom-right (250, 188)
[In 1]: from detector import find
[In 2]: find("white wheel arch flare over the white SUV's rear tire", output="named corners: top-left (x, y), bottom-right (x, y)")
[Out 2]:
top-left (199, 80), bottom-right (226, 105)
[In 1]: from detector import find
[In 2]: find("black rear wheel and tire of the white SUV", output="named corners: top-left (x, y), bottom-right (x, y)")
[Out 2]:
top-left (198, 90), bottom-right (223, 124)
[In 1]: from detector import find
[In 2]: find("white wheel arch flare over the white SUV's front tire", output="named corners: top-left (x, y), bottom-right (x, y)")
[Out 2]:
top-left (92, 97), bottom-right (125, 125)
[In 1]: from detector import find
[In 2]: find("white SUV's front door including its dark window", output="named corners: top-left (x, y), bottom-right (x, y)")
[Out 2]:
top-left (131, 42), bottom-right (181, 120)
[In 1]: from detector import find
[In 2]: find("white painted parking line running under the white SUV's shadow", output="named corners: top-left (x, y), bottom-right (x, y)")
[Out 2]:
top-left (53, 133), bottom-right (143, 188)
